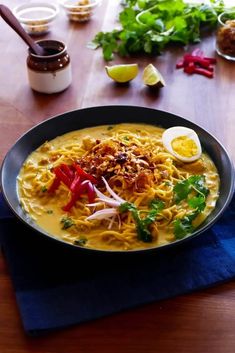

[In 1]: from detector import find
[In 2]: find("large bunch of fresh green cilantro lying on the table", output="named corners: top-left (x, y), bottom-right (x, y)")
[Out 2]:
top-left (88, 0), bottom-right (224, 60)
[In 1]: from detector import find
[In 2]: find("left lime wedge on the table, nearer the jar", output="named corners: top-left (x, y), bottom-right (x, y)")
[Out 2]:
top-left (105, 64), bottom-right (139, 83)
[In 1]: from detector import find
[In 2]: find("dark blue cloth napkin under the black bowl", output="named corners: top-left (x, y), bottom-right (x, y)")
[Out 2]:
top-left (0, 192), bottom-right (235, 335)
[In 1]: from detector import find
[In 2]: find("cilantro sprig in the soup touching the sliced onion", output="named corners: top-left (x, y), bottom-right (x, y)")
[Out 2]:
top-left (119, 200), bottom-right (164, 243)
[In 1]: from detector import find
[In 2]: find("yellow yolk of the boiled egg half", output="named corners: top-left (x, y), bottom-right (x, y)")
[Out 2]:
top-left (171, 136), bottom-right (198, 157)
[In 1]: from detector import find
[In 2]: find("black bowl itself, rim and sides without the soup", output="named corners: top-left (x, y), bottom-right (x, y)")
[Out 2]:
top-left (1, 106), bottom-right (234, 253)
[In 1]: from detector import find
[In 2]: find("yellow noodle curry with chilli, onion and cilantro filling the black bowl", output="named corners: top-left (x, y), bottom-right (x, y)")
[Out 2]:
top-left (18, 123), bottom-right (220, 251)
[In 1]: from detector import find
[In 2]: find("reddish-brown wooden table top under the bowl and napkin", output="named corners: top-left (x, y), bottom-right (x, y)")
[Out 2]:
top-left (0, 0), bottom-right (235, 353)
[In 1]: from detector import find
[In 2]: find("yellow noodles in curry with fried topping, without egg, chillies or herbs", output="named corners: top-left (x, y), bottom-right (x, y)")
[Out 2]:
top-left (18, 124), bottom-right (219, 250)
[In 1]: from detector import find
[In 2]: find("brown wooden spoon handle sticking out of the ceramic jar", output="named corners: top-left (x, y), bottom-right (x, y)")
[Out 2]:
top-left (0, 4), bottom-right (43, 55)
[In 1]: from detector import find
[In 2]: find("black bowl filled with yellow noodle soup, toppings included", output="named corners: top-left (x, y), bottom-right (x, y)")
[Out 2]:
top-left (1, 106), bottom-right (234, 253)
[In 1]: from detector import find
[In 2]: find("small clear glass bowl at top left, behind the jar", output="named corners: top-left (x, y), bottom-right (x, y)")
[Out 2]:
top-left (13, 2), bottom-right (59, 25)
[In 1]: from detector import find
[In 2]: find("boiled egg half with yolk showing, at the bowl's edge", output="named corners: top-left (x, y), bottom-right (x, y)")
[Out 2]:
top-left (162, 126), bottom-right (202, 162)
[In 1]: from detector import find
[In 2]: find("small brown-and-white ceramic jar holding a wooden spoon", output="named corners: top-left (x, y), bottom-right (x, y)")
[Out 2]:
top-left (27, 39), bottom-right (72, 94)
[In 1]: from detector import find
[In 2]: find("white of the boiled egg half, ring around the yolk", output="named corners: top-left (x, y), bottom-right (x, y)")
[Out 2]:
top-left (162, 126), bottom-right (202, 162)
